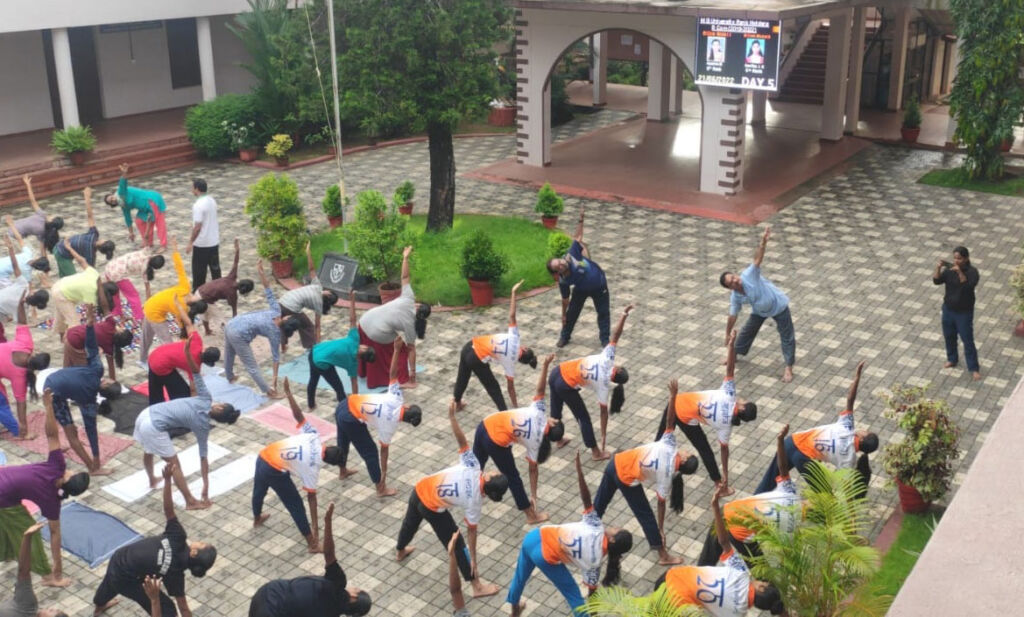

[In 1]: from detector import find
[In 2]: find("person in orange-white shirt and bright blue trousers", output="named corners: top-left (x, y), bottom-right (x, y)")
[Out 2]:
top-left (505, 450), bottom-right (633, 617)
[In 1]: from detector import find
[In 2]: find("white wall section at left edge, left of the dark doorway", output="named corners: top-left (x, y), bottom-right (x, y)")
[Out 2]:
top-left (0, 32), bottom-right (53, 135)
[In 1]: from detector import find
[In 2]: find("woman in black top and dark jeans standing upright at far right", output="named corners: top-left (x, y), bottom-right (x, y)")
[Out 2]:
top-left (932, 247), bottom-right (981, 381)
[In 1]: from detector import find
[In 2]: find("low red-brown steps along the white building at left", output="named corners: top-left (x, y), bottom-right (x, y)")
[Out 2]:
top-left (0, 135), bottom-right (199, 207)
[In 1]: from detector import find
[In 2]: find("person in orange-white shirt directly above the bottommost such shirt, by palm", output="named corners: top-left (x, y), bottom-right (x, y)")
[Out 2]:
top-left (697, 425), bottom-right (801, 566)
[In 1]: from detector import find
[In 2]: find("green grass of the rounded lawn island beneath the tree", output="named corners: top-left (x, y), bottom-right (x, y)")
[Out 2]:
top-left (295, 214), bottom-right (557, 306)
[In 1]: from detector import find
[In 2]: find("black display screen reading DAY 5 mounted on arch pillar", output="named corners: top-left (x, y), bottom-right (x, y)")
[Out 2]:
top-left (693, 17), bottom-right (779, 92)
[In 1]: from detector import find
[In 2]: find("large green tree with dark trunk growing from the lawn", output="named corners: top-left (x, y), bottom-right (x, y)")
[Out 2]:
top-left (336, 0), bottom-right (509, 231)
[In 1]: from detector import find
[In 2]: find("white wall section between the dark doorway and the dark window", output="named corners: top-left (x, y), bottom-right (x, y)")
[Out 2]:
top-left (95, 26), bottom-right (203, 118)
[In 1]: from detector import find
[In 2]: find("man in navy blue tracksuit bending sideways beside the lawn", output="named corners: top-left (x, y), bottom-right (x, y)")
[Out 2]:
top-left (548, 208), bottom-right (611, 347)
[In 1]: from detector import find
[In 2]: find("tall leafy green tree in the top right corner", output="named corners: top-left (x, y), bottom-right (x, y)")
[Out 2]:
top-left (949, 0), bottom-right (1024, 180)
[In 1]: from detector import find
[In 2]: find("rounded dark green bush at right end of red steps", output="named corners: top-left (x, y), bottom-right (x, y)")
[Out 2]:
top-left (185, 94), bottom-right (261, 159)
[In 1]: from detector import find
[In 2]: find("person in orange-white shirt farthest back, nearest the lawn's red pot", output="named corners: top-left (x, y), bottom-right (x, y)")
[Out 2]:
top-left (453, 280), bottom-right (537, 411)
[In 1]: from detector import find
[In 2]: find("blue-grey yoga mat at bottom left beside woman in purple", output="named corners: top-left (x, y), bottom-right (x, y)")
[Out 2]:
top-left (40, 501), bottom-right (142, 568)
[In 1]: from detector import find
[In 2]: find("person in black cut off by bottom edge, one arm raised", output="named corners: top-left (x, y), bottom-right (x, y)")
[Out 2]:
top-left (249, 502), bottom-right (373, 617)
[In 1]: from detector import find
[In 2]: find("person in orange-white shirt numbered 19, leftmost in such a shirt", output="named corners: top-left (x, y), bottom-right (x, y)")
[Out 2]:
top-left (253, 378), bottom-right (341, 553)
